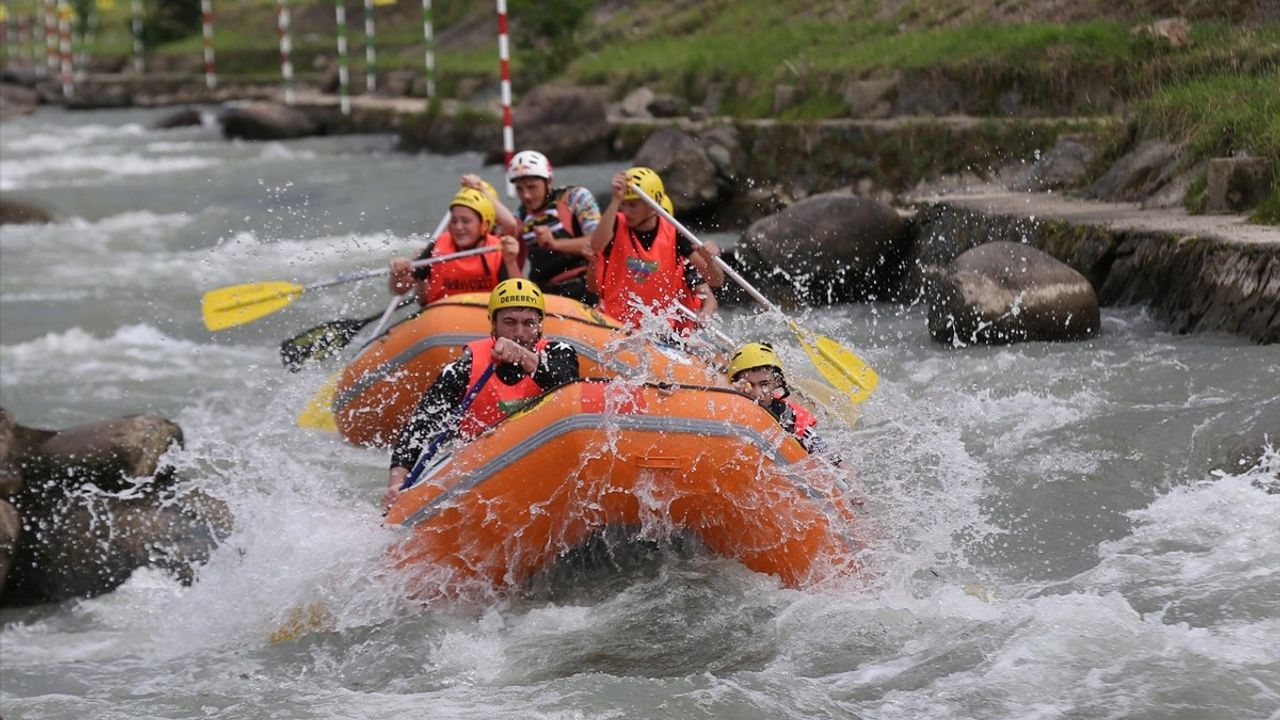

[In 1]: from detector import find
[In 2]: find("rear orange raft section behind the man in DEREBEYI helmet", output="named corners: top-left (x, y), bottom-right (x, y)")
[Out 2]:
top-left (332, 292), bottom-right (727, 446)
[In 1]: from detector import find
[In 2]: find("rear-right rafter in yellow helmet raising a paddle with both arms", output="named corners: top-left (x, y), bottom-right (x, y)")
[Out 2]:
top-left (591, 168), bottom-right (724, 329)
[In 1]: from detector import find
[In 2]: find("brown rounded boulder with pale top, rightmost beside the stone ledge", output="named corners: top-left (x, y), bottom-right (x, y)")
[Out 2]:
top-left (928, 241), bottom-right (1101, 345)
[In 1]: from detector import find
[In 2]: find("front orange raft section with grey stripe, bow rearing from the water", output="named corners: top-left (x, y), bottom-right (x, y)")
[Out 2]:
top-left (387, 379), bottom-right (860, 594)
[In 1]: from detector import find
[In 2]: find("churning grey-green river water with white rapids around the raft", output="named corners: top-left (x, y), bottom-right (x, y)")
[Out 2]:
top-left (0, 110), bottom-right (1280, 720)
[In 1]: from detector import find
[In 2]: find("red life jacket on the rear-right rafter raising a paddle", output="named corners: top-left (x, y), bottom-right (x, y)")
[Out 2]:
top-left (596, 213), bottom-right (703, 329)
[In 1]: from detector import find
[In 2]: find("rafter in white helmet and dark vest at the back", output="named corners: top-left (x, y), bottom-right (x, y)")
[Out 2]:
top-left (481, 150), bottom-right (600, 305)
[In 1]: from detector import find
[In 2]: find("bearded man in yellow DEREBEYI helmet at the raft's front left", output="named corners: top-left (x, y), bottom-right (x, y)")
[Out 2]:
top-left (383, 279), bottom-right (579, 509)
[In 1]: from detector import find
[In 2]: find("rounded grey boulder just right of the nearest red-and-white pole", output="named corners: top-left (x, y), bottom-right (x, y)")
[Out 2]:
top-left (512, 85), bottom-right (613, 165)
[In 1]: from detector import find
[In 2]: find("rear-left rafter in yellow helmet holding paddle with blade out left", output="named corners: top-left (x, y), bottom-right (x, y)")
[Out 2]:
top-left (388, 181), bottom-right (524, 305)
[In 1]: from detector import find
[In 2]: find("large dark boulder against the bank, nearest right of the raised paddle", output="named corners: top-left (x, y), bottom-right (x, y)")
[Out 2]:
top-left (739, 193), bottom-right (908, 304)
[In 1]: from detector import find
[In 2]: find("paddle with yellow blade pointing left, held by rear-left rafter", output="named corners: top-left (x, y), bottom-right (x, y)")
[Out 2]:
top-left (200, 246), bottom-right (500, 331)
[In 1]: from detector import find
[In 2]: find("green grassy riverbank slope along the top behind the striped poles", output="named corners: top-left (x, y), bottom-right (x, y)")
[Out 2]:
top-left (45, 0), bottom-right (1280, 223)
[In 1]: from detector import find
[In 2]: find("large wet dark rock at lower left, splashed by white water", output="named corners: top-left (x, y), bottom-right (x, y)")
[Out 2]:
top-left (0, 409), bottom-right (230, 605)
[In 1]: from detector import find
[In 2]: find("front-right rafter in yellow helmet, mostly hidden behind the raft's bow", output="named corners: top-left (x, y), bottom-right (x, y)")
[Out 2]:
top-left (724, 342), bottom-right (840, 465)
